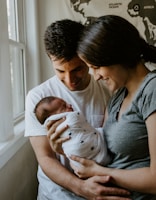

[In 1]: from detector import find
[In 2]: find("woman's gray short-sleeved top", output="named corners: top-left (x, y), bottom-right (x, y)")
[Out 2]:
top-left (104, 71), bottom-right (156, 200)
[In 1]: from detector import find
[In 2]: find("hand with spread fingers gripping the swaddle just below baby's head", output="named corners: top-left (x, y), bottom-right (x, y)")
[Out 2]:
top-left (46, 118), bottom-right (70, 155)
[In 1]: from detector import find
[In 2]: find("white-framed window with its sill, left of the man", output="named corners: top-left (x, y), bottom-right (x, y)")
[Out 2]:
top-left (0, 0), bottom-right (40, 169)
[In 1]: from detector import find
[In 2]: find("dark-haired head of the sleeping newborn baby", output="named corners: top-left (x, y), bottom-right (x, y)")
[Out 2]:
top-left (34, 96), bottom-right (73, 124)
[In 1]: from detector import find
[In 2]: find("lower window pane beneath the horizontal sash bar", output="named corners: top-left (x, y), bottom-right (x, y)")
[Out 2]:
top-left (10, 45), bottom-right (25, 119)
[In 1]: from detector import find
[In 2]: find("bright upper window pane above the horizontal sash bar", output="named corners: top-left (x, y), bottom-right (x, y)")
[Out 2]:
top-left (7, 0), bottom-right (17, 40)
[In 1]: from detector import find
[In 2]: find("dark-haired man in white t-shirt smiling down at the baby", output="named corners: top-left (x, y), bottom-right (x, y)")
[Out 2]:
top-left (25, 20), bottom-right (130, 200)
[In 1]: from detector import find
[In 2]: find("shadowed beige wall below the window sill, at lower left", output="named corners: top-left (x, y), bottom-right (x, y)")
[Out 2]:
top-left (0, 142), bottom-right (38, 200)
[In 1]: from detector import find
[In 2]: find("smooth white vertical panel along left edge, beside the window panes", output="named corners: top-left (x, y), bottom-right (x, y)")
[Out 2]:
top-left (0, 0), bottom-right (13, 142)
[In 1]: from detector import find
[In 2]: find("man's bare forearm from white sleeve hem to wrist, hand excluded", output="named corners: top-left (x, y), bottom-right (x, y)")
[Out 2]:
top-left (30, 136), bottom-right (79, 190)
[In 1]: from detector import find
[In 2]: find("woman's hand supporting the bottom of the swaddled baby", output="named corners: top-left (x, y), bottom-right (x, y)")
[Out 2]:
top-left (70, 155), bottom-right (98, 178)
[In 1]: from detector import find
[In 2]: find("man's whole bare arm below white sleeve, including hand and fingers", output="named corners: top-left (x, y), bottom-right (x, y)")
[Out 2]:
top-left (30, 136), bottom-right (128, 200)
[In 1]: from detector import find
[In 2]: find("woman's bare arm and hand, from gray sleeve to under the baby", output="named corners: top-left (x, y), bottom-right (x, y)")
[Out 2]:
top-left (71, 113), bottom-right (156, 194)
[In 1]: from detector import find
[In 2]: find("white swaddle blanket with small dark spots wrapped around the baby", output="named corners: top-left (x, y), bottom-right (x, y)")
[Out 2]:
top-left (44, 111), bottom-right (110, 165)
